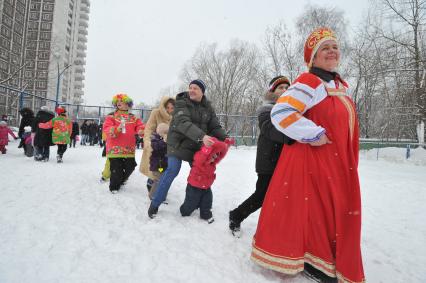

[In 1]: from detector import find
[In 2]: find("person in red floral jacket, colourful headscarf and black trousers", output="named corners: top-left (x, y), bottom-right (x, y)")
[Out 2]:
top-left (103, 93), bottom-right (145, 194)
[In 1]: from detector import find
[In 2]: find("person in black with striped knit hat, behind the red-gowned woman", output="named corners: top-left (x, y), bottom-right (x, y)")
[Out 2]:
top-left (229, 76), bottom-right (294, 237)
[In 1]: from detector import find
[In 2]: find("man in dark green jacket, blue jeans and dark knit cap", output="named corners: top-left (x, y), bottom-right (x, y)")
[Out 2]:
top-left (148, 80), bottom-right (227, 218)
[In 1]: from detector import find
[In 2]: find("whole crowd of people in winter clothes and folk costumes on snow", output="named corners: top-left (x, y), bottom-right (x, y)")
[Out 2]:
top-left (0, 28), bottom-right (365, 282)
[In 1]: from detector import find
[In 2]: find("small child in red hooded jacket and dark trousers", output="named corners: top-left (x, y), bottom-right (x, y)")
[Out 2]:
top-left (180, 138), bottom-right (234, 224)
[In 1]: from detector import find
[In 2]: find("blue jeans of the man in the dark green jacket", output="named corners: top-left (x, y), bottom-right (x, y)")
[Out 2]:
top-left (151, 156), bottom-right (182, 207)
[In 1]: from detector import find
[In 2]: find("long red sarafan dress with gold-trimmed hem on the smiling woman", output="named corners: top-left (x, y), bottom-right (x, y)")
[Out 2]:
top-left (251, 74), bottom-right (365, 282)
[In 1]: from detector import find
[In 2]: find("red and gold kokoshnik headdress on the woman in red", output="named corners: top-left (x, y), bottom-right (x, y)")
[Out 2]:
top-left (304, 27), bottom-right (337, 68)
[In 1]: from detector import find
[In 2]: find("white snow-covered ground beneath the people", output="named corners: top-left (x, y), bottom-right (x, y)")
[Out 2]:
top-left (0, 142), bottom-right (426, 283)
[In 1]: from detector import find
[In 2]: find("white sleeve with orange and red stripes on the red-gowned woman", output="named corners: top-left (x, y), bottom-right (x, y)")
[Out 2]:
top-left (271, 73), bottom-right (327, 143)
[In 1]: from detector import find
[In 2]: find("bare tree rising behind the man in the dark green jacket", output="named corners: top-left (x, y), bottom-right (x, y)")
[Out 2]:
top-left (181, 40), bottom-right (262, 129)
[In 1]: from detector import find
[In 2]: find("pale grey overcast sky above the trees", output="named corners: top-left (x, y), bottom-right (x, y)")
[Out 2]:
top-left (84, 0), bottom-right (368, 104)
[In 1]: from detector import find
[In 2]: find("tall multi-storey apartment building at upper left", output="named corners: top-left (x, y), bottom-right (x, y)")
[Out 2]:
top-left (0, 0), bottom-right (90, 123)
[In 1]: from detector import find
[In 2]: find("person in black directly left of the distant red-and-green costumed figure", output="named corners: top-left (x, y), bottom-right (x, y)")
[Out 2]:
top-left (32, 106), bottom-right (55, 162)
